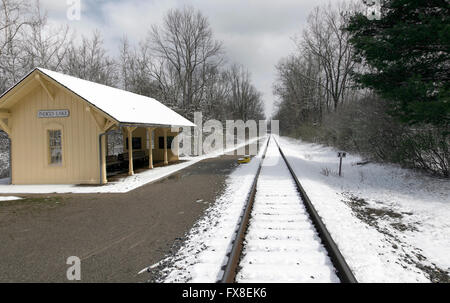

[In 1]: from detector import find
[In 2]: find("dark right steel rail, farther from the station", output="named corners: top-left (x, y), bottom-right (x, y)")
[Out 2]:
top-left (274, 138), bottom-right (358, 283)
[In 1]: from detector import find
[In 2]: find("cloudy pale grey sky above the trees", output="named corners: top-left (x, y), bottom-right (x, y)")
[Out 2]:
top-left (41, 0), bottom-right (329, 116)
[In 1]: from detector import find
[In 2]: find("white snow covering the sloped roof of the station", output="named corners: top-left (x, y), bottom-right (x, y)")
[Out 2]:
top-left (37, 68), bottom-right (195, 126)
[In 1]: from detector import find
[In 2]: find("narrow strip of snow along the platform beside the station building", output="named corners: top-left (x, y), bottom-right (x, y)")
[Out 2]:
top-left (0, 138), bottom-right (258, 194)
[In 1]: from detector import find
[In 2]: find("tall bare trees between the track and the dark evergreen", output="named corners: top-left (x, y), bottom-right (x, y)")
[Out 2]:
top-left (274, 3), bottom-right (359, 134)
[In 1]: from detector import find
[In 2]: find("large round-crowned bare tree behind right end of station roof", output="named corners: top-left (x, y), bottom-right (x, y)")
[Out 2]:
top-left (149, 7), bottom-right (222, 115)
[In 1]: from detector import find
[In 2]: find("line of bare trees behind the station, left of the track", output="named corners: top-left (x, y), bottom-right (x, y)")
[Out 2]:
top-left (0, 0), bottom-right (264, 121)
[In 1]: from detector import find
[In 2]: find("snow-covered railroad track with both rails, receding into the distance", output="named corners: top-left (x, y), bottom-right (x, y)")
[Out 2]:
top-left (218, 137), bottom-right (357, 283)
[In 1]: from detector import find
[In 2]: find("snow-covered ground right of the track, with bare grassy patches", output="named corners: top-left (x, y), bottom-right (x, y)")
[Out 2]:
top-left (278, 137), bottom-right (450, 282)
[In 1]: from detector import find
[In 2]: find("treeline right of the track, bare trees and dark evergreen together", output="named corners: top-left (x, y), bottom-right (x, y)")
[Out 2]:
top-left (274, 0), bottom-right (450, 177)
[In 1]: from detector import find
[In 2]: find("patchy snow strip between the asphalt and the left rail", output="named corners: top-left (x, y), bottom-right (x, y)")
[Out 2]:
top-left (151, 138), bottom-right (265, 282)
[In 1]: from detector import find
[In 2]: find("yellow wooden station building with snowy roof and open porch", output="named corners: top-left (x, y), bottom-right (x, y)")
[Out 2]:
top-left (0, 68), bottom-right (195, 184)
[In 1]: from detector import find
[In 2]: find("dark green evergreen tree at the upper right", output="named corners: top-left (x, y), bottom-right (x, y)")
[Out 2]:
top-left (347, 0), bottom-right (450, 130)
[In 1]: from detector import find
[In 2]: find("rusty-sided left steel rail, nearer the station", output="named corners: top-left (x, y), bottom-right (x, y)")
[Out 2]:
top-left (217, 136), bottom-right (271, 283)
